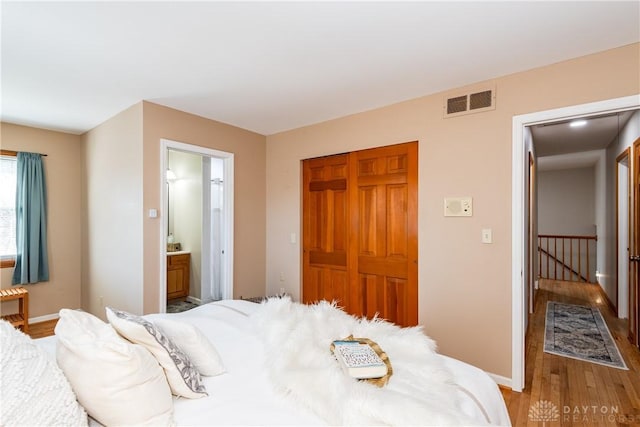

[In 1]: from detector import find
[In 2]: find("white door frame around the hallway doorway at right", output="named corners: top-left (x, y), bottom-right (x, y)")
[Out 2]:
top-left (511, 94), bottom-right (640, 392)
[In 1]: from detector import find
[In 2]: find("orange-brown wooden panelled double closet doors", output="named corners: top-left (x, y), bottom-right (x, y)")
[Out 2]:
top-left (302, 142), bottom-right (418, 326)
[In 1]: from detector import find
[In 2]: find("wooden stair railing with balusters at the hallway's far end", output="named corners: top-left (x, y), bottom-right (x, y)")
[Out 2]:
top-left (538, 234), bottom-right (598, 282)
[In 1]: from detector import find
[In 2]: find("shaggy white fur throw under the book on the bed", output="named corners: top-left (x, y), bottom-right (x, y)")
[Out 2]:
top-left (251, 298), bottom-right (477, 426)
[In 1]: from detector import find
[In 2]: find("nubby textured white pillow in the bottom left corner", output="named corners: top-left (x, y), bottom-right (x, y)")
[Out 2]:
top-left (0, 320), bottom-right (87, 426)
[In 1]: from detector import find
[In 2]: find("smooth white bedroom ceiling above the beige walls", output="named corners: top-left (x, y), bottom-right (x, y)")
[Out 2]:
top-left (1, 1), bottom-right (640, 135)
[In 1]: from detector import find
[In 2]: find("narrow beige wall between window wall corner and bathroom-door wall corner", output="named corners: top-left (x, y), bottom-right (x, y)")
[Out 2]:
top-left (82, 103), bottom-right (143, 319)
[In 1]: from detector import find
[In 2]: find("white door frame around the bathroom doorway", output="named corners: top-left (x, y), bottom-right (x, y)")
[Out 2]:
top-left (158, 138), bottom-right (234, 313)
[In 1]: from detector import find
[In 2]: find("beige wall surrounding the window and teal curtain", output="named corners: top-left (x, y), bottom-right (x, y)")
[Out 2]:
top-left (0, 123), bottom-right (82, 318)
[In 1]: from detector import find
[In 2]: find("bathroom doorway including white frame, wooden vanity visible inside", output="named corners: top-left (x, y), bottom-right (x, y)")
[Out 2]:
top-left (159, 139), bottom-right (234, 313)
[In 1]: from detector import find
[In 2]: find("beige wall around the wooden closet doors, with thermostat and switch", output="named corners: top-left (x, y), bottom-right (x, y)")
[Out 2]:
top-left (267, 44), bottom-right (640, 378)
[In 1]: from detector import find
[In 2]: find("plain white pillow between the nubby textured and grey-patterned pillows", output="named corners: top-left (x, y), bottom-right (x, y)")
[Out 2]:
top-left (55, 309), bottom-right (173, 425)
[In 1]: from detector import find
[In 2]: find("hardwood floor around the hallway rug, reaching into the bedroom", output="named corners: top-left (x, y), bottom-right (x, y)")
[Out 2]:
top-left (502, 280), bottom-right (640, 427)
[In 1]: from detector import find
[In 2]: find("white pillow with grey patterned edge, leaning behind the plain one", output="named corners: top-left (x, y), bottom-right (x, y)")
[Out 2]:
top-left (106, 307), bottom-right (207, 399)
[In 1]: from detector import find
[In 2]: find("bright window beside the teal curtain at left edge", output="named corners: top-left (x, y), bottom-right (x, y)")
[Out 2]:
top-left (0, 154), bottom-right (17, 267)
